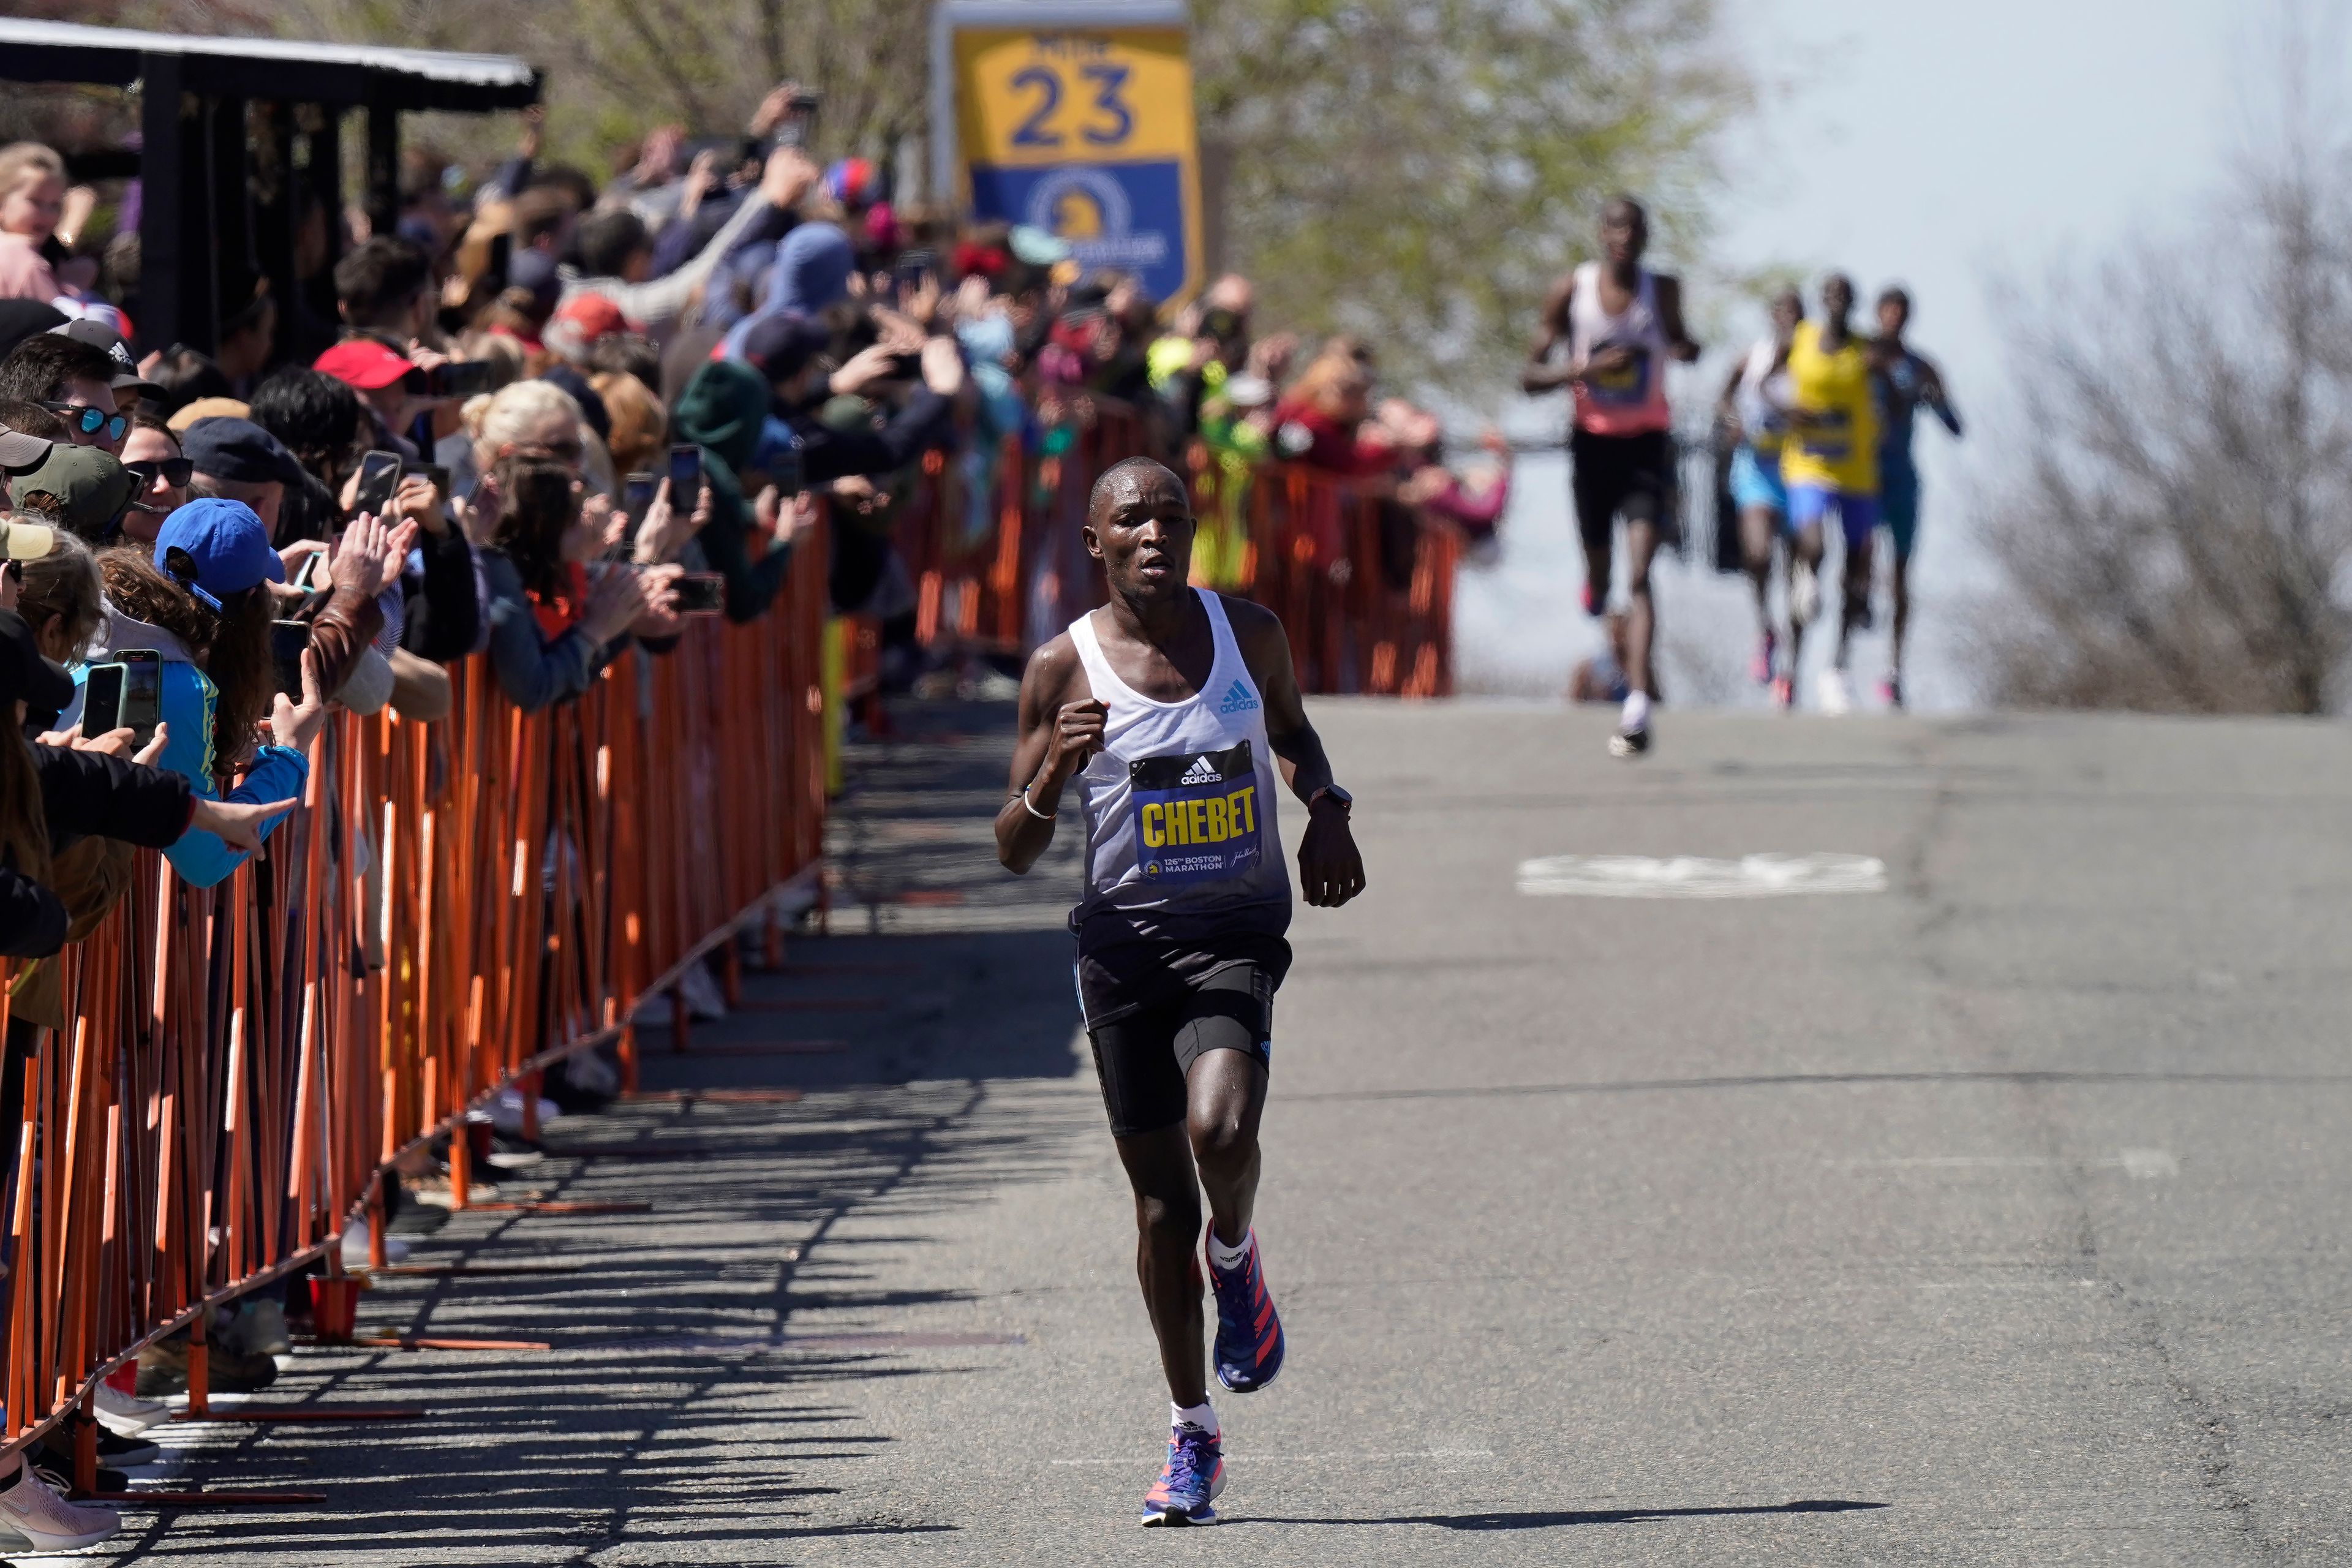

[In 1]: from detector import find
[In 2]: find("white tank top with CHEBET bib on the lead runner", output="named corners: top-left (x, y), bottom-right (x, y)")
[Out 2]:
top-left (1070, 590), bottom-right (1291, 948)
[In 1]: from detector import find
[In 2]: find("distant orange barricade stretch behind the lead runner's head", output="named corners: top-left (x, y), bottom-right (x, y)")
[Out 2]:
top-left (894, 399), bottom-right (1461, 696)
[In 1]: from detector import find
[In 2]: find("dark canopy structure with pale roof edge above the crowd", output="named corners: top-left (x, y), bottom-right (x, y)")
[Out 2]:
top-left (0, 19), bottom-right (541, 353)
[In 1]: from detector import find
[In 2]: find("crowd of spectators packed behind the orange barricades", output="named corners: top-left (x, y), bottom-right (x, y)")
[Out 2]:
top-left (0, 89), bottom-right (1507, 1537)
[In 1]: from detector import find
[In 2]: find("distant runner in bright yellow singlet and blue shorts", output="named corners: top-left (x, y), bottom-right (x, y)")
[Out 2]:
top-left (1781, 273), bottom-right (1879, 712)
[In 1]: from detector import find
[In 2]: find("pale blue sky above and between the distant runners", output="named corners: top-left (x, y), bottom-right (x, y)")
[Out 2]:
top-left (1458, 0), bottom-right (2267, 707)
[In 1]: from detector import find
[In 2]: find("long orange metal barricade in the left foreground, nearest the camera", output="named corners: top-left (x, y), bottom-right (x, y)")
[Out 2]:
top-left (0, 527), bottom-right (826, 1453)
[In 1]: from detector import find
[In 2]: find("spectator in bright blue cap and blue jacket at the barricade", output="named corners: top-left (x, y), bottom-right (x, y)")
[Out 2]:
top-left (59, 501), bottom-right (327, 886)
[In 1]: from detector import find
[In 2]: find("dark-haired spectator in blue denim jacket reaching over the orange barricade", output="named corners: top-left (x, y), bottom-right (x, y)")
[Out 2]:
top-left (480, 454), bottom-right (677, 712)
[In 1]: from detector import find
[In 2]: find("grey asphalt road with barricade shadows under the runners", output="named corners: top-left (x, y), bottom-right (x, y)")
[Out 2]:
top-left (105, 703), bottom-right (2352, 1568)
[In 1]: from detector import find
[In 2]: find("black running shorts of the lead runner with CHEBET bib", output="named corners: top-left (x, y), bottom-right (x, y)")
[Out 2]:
top-left (1087, 962), bottom-right (1282, 1138)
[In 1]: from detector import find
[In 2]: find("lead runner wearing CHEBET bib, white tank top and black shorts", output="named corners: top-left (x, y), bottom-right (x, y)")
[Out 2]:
top-left (997, 458), bottom-right (1364, 1526)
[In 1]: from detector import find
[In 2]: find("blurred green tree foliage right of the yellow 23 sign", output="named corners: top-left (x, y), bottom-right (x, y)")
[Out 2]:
top-left (1193, 0), bottom-right (1750, 390)
